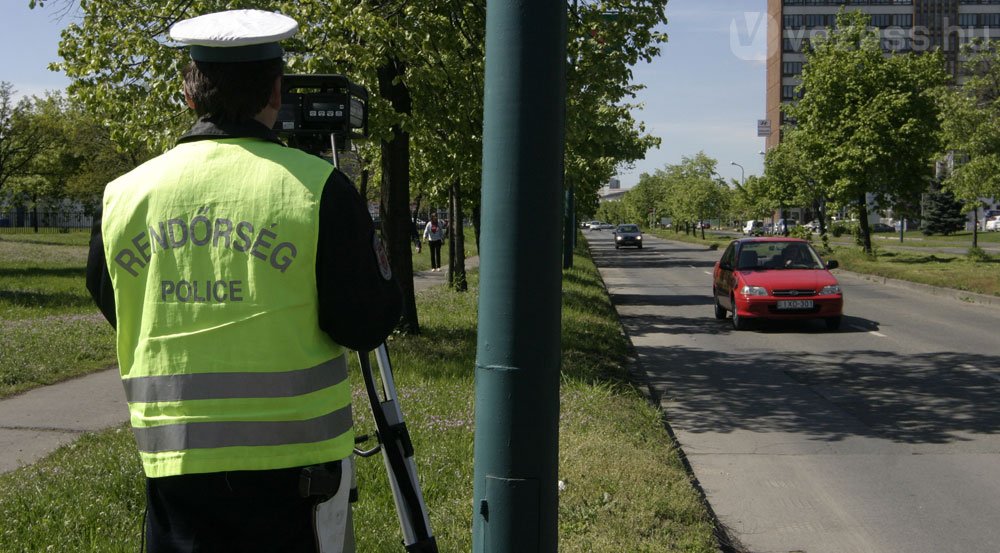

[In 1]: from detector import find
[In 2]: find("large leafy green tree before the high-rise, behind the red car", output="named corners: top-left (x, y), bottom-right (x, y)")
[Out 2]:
top-left (787, 10), bottom-right (948, 254)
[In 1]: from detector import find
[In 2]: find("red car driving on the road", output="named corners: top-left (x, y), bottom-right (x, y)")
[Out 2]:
top-left (712, 236), bottom-right (844, 330)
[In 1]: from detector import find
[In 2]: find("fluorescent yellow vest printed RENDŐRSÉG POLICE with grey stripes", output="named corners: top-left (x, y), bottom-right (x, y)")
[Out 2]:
top-left (101, 138), bottom-right (354, 478)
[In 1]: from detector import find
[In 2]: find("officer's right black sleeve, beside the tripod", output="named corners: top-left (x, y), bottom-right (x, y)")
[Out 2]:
top-left (316, 170), bottom-right (403, 351)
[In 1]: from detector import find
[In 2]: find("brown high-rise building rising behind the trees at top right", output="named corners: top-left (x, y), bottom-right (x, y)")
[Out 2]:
top-left (767, 0), bottom-right (1000, 148)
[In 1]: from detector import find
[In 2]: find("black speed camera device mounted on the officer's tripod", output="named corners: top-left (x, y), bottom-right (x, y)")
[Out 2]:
top-left (274, 75), bottom-right (368, 156)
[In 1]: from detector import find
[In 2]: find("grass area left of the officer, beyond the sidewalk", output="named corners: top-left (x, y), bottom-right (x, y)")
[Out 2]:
top-left (0, 233), bottom-right (116, 397)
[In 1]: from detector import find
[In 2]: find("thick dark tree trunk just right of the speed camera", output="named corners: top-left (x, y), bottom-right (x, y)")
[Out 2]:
top-left (378, 58), bottom-right (420, 334)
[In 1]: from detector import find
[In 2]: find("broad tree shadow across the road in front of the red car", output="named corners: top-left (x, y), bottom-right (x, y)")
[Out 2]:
top-left (640, 347), bottom-right (1000, 444)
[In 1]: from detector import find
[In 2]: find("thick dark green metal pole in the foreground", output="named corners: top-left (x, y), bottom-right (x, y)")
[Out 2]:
top-left (472, 0), bottom-right (566, 553)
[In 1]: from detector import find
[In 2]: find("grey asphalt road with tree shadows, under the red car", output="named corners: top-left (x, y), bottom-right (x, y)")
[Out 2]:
top-left (586, 226), bottom-right (1000, 553)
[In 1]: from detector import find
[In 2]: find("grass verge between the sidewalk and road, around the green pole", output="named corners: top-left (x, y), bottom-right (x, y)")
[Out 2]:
top-left (0, 244), bottom-right (716, 553)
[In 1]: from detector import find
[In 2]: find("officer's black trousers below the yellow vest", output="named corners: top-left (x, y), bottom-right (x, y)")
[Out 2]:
top-left (146, 468), bottom-right (317, 553)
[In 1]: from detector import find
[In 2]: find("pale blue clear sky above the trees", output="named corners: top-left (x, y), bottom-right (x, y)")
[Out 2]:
top-left (0, 0), bottom-right (767, 188)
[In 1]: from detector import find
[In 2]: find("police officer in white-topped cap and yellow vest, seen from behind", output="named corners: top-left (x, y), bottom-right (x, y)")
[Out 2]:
top-left (87, 10), bottom-right (401, 553)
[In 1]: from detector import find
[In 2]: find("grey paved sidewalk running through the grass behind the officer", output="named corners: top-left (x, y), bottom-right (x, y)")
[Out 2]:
top-left (0, 257), bottom-right (479, 474)
